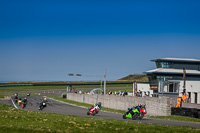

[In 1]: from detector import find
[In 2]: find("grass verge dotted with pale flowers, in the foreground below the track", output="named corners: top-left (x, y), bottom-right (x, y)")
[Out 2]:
top-left (0, 104), bottom-right (200, 133)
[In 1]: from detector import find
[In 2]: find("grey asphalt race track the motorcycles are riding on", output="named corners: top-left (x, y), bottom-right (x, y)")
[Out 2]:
top-left (0, 96), bottom-right (200, 128)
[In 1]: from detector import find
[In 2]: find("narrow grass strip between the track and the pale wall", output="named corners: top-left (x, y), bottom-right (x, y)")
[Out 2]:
top-left (51, 96), bottom-right (200, 123)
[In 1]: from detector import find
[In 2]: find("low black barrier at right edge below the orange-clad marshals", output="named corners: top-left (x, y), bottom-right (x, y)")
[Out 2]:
top-left (171, 107), bottom-right (200, 119)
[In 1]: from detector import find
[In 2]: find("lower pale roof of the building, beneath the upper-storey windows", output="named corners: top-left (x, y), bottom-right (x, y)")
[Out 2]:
top-left (145, 68), bottom-right (200, 75)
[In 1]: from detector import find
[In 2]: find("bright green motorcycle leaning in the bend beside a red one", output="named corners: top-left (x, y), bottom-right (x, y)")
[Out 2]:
top-left (123, 106), bottom-right (140, 120)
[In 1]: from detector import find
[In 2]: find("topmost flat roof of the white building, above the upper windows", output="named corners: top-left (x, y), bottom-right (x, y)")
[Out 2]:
top-left (151, 58), bottom-right (200, 63)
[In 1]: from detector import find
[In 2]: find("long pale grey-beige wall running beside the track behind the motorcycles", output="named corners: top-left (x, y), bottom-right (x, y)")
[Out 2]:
top-left (67, 93), bottom-right (176, 116)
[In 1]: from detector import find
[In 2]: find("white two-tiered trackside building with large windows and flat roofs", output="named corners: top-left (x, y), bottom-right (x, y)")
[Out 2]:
top-left (133, 58), bottom-right (200, 104)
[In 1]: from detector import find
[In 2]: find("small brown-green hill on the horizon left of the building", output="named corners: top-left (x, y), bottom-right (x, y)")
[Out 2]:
top-left (118, 74), bottom-right (149, 82)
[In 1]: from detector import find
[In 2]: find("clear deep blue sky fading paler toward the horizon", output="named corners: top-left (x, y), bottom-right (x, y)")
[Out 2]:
top-left (0, 0), bottom-right (200, 81)
